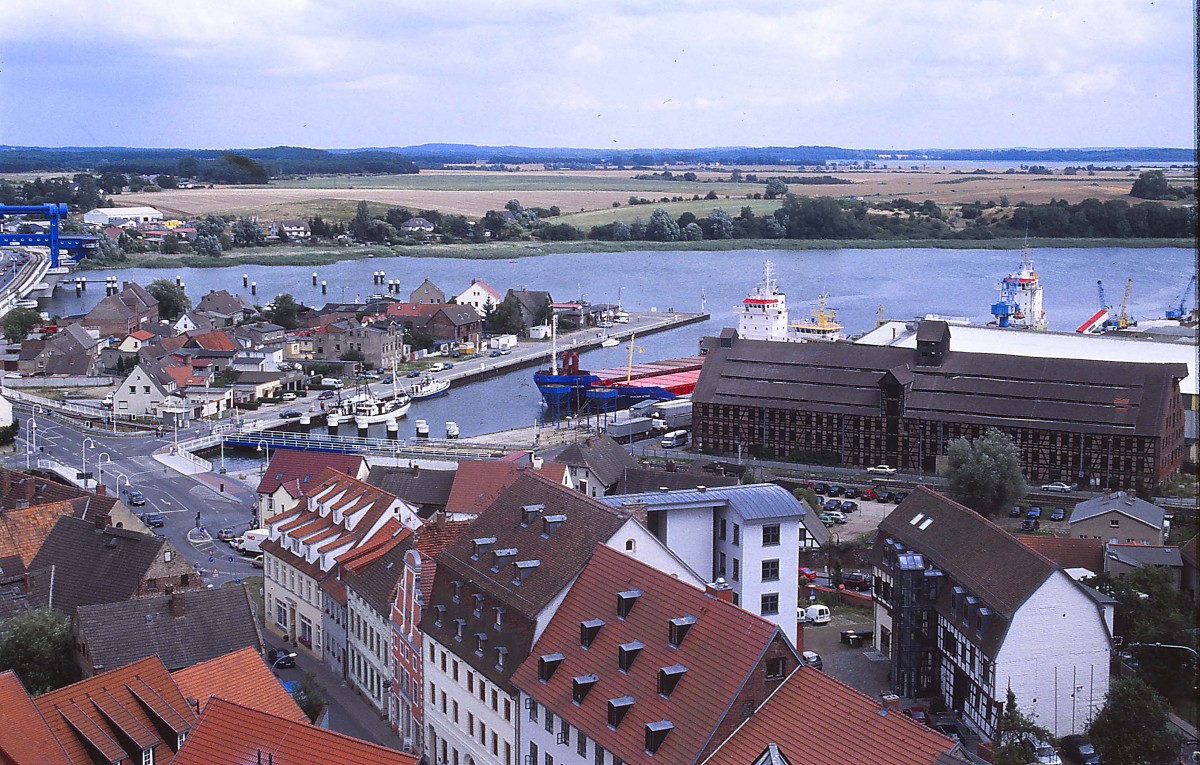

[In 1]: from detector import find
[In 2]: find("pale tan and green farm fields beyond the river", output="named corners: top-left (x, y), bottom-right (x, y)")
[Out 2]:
top-left (82, 168), bottom-right (1192, 220)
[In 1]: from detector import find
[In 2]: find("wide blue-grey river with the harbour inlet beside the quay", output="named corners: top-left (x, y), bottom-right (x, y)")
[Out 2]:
top-left (42, 247), bottom-right (1195, 436)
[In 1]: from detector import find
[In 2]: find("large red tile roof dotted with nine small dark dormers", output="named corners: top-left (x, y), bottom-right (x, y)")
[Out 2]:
top-left (512, 544), bottom-right (796, 765)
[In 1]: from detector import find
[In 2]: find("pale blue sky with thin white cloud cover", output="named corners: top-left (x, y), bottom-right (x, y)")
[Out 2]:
top-left (0, 0), bottom-right (1195, 149)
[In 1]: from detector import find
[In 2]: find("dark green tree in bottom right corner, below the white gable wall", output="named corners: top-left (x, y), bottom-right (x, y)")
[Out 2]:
top-left (1087, 677), bottom-right (1180, 765)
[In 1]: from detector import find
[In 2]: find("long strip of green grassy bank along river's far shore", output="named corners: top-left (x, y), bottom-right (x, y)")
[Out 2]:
top-left (82, 239), bottom-right (1196, 270)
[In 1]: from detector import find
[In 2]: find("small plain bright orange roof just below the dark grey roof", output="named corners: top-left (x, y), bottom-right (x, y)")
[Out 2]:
top-left (170, 647), bottom-right (308, 723)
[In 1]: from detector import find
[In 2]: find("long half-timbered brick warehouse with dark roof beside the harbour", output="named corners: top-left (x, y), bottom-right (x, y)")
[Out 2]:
top-left (692, 320), bottom-right (1187, 487)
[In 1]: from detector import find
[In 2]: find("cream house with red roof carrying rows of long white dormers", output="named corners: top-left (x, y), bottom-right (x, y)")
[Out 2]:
top-left (263, 467), bottom-right (420, 663)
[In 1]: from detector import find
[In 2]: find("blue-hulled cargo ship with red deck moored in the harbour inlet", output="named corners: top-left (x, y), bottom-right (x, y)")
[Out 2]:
top-left (533, 341), bottom-right (704, 418)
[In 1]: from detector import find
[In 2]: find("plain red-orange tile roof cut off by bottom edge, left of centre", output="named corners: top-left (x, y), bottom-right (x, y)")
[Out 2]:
top-left (172, 698), bottom-right (418, 765)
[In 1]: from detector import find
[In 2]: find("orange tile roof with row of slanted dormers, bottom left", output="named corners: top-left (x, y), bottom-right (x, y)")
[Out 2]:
top-left (34, 656), bottom-right (196, 763)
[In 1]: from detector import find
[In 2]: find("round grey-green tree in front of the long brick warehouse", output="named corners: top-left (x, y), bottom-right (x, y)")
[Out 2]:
top-left (946, 428), bottom-right (1028, 516)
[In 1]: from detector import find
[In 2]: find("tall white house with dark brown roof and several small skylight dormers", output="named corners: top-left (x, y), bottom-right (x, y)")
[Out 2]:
top-left (421, 470), bottom-right (703, 763)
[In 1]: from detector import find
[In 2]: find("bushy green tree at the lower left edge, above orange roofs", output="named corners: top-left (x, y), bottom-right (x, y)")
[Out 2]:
top-left (0, 608), bottom-right (76, 695)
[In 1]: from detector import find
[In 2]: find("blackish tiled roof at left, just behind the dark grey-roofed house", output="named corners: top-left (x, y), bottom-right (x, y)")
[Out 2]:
top-left (29, 516), bottom-right (178, 614)
